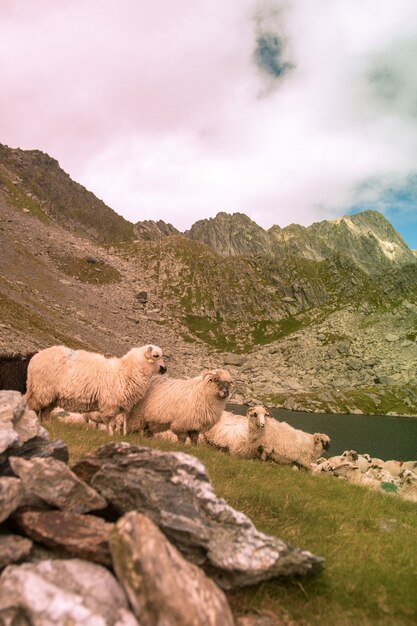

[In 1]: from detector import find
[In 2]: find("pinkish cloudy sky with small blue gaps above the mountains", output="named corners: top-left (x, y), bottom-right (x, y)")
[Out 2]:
top-left (0, 0), bottom-right (417, 248)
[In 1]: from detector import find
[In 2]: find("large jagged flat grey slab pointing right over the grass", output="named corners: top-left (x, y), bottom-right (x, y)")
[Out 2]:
top-left (73, 442), bottom-right (323, 589)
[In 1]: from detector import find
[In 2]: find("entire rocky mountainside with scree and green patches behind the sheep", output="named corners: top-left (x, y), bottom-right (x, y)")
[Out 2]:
top-left (0, 141), bottom-right (417, 414)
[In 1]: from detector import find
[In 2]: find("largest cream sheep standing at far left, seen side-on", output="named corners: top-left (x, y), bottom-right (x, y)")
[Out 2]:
top-left (25, 344), bottom-right (166, 434)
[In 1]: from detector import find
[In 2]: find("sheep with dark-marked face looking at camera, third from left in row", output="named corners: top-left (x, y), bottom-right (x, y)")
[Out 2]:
top-left (204, 405), bottom-right (272, 459)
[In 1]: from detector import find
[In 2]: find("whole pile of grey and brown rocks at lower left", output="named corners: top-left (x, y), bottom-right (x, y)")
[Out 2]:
top-left (0, 391), bottom-right (323, 626)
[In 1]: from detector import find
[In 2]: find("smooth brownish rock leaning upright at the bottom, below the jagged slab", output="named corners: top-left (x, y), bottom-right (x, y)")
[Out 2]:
top-left (110, 511), bottom-right (234, 626)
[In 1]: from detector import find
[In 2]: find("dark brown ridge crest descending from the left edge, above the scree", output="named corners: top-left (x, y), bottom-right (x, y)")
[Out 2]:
top-left (0, 144), bottom-right (134, 243)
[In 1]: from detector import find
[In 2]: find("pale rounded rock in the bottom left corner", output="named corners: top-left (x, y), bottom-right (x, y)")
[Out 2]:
top-left (0, 559), bottom-right (140, 626)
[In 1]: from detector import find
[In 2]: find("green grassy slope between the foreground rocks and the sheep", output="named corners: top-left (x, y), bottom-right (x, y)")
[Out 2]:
top-left (48, 423), bottom-right (417, 626)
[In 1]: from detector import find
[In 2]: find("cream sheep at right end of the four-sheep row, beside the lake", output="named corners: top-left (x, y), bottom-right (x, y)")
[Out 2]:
top-left (260, 418), bottom-right (330, 469)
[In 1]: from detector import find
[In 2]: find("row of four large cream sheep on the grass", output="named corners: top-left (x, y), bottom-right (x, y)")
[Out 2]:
top-left (26, 345), bottom-right (330, 468)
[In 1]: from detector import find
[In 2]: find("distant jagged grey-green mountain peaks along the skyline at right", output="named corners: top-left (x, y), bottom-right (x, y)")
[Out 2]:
top-left (184, 211), bottom-right (415, 273)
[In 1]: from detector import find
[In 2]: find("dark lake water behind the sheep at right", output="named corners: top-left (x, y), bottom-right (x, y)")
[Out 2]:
top-left (227, 404), bottom-right (417, 461)
